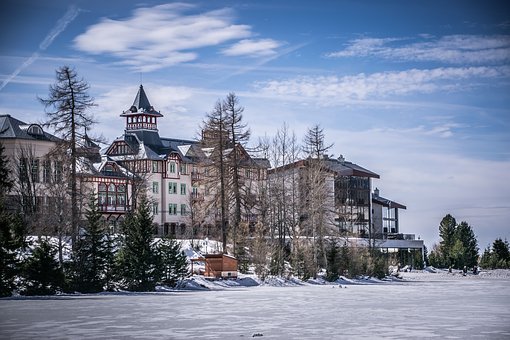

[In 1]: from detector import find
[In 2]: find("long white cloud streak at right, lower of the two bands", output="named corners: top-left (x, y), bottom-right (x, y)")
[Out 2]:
top-left (256, 66), bottom-right (510, 103)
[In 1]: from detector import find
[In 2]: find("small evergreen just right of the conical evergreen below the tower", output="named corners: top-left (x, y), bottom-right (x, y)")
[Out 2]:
top-left (157, 237), bottom-right (189, 287)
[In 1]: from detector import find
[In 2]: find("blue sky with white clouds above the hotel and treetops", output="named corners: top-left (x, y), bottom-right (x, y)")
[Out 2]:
top-left (0, 0), bottom-right (510, 250)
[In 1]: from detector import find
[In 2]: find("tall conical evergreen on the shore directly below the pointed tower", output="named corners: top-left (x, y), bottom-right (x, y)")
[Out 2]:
top-left (116, 195), bottom-right (159, 291)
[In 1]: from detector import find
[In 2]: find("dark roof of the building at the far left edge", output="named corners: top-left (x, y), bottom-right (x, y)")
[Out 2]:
top-left (0, 115), bottom-right (60, 142)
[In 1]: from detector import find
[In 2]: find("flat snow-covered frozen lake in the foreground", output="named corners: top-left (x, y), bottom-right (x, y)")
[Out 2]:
top-left (0, 274), bottom-right (510, 339)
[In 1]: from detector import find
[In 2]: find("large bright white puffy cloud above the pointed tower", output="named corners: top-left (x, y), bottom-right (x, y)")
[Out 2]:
top-left (74, 3), bottom-right (281, 72)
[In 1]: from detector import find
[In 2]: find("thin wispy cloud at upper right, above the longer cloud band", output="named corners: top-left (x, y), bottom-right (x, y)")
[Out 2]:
top-left (327, 35), bottom-right (510, 65)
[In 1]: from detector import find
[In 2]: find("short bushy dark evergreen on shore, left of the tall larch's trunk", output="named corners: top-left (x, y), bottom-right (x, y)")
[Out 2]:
top-left (21, 240), bottom-right (64, 295)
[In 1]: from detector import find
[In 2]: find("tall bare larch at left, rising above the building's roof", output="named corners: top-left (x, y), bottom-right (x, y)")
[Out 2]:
top-left (39, 66), bottom-right (95, 240)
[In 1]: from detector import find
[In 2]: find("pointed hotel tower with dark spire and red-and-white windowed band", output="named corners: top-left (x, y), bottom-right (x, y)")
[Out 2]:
top-left (120, 85), bottom-right (163, 151)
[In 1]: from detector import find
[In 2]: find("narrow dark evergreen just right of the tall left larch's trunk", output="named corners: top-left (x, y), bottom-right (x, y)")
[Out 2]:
top-left (73, 194), bottom-right (113, 293)
